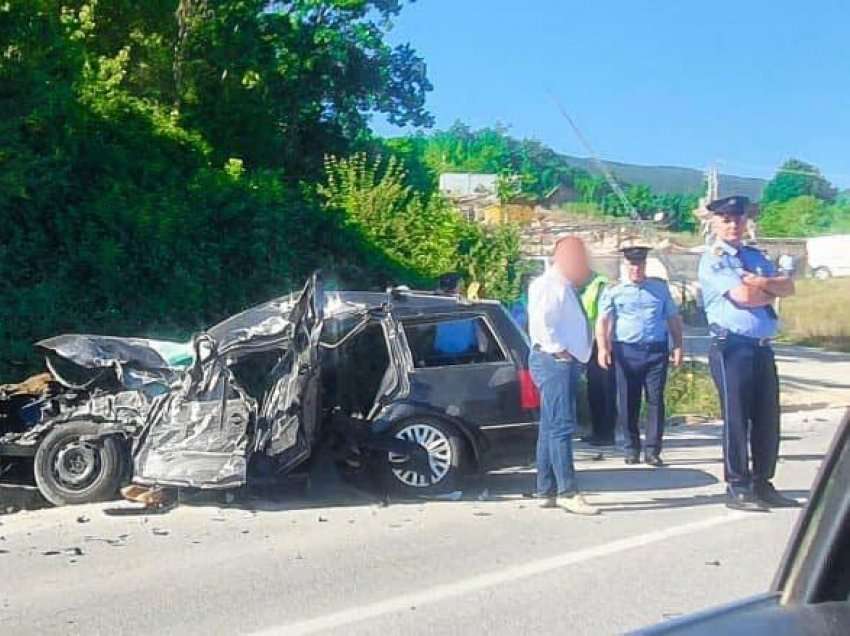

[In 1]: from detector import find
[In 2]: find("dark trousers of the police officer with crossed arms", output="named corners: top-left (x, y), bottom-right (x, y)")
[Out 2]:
top-left (708, 336), bottom-right (779, 489)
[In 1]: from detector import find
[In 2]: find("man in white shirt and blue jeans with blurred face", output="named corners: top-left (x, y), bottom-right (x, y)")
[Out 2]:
top-left (528, 236), bottom-right (599, 515)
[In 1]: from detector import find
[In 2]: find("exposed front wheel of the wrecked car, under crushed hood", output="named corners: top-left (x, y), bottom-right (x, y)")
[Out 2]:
top-left (34, 422), bottom-right (129, 506)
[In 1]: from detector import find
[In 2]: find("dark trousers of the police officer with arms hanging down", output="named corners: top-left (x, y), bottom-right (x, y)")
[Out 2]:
top-left (614, 342), bottom-right (669, 455)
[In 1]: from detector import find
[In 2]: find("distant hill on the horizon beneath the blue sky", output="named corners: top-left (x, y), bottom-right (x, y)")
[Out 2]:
top-left (561, 155), bottom-right (767, 201)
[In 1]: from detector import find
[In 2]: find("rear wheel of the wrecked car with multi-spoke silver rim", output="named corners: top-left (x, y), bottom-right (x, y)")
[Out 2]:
top-left (381, 417), bottom-right (467, 496)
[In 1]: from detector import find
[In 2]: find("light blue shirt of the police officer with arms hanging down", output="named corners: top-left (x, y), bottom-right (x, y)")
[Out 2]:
top-left (599, 278), bottom-right (679, 344)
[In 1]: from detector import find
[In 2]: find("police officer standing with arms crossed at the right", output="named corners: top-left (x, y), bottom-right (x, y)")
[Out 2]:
top-left (699, 196), bottom-right (797, 510)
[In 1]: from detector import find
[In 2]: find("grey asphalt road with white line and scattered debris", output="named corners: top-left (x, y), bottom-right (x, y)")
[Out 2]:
top-left (0, 409), bottom-right (842, 635)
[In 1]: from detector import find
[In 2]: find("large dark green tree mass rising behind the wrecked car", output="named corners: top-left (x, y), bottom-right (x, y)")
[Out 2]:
top-left (0, 0), bottom-right (438, 377)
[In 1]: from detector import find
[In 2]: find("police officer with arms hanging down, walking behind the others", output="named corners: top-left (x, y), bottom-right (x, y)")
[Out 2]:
top-left (596, 246), bottom-right (682, 466)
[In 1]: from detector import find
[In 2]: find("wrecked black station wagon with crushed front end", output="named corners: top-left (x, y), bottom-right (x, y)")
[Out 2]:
top-left (0, 274), bottom-right (538, 505)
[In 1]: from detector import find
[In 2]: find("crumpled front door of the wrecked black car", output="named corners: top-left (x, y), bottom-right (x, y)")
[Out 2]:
top-left (134, 275), bottom-right (323, 488)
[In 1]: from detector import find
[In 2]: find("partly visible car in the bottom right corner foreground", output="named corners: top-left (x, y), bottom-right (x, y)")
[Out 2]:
top-left (636, 411), bottom-right (850, 636)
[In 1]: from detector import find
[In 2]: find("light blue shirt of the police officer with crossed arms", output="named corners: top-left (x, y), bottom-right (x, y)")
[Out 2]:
top-left (699, 241), bottom-right (779, 338)
